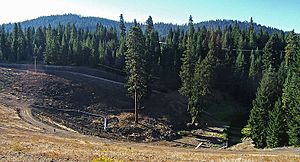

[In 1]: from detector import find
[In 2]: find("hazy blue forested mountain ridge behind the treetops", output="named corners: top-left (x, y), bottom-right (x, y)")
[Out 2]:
top-left (3, 14), bottom-right (282, 36)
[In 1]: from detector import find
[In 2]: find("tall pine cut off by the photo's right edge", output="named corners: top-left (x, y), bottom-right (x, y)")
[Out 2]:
top-left (282, 31), bottom-right (300, 146)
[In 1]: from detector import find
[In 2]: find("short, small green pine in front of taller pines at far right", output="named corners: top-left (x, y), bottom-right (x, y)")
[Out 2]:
top-left (266, 98), bottom-right (286, 148)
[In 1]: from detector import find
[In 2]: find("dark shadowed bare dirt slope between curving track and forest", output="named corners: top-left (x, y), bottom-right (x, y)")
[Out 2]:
top-left (0, 68), bottom-right (186, 141)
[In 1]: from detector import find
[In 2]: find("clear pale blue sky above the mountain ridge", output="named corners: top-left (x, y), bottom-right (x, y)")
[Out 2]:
top-left (0, 0), bottom-right (300, 33)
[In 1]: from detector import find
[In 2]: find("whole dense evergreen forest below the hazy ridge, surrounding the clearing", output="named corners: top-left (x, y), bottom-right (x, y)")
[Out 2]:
top-left (0, 15), bottom-right (300, 148)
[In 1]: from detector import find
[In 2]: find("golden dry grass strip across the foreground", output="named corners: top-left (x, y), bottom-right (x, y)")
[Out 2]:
top-left (0, 106), bottom-right (300, 162)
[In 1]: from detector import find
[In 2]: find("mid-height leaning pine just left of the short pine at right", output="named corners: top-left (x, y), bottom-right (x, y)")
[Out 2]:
top-left (249, 67), bottom-right (277, 148)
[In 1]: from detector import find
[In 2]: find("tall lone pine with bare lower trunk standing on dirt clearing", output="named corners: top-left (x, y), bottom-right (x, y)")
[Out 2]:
top-left (125, 21), bottom-right (148, 123)
